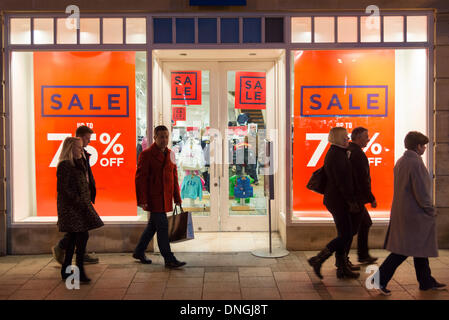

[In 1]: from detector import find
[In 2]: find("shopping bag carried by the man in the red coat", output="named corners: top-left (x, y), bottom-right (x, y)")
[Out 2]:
top-left (167, 206), bottom-right (194, 242)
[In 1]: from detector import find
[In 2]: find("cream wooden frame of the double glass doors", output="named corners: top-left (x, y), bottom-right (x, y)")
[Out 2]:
top-left (153, 53), bottom-right (283, 232)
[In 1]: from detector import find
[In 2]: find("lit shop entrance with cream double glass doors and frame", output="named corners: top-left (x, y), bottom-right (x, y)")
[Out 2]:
top-left (153, 50), bottom-right (277, 232)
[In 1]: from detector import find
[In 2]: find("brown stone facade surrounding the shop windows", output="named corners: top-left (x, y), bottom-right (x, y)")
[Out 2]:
top-left (0, 0), bottom-right (449, 255)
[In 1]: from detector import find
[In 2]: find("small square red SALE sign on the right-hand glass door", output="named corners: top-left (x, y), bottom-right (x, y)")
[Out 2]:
top-left (235, 71), bottom-right (267, 109)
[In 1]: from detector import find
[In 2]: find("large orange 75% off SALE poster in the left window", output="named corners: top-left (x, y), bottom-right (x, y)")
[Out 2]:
top-left (34, 52), bottom-right (137, 216)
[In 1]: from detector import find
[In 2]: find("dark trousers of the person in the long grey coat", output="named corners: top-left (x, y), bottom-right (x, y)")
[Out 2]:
top-left (379, 253), bottom-right (436, 289)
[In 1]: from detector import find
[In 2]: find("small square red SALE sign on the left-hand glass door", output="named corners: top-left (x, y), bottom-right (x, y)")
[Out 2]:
top-left (171, 70), bottom-right (201, 106)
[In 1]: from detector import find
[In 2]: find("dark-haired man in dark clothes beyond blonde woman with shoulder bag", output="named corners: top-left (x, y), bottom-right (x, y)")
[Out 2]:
top-left (348, 127), bottom-right (377, 264)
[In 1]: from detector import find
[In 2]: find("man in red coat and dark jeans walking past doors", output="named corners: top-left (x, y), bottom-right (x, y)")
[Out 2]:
top-left (133, 126), bottom-right (186, 268)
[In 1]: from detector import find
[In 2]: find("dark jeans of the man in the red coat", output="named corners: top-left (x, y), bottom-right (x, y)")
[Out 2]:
top-left (134, 212), bottom-right (176, 262)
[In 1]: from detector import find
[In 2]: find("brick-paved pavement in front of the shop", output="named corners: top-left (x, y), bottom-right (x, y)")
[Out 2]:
top-left (0, 250), bottom-right (449, 300)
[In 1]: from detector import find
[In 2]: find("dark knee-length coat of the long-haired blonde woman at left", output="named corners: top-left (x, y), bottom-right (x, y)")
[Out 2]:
top-left (56, 160), bottom-right (104, 232)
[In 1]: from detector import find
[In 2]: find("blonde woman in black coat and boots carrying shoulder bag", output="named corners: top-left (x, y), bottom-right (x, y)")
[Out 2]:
top-left (308, 127), bottom-right (360, 279)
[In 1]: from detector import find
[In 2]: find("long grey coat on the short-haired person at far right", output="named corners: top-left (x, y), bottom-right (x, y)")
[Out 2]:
top-left (384, 150), bottom-right (438, 258)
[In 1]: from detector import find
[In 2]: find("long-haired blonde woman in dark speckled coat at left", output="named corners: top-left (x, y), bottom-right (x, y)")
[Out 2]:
top-left (56, 137), bottom-right (104, 282)
